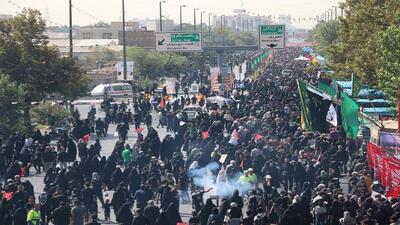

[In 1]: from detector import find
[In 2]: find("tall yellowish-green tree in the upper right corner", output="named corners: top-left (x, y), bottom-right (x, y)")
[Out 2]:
top-left (327, 0), bottom-right (400, 82)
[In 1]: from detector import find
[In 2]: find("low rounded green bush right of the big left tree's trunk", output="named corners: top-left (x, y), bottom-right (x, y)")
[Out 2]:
top-left (32, 102), bottom-right (70, 125)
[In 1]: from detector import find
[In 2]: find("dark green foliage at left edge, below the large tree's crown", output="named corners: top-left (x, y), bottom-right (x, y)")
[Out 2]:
top-left (0, 74), bottom-right (24, 136)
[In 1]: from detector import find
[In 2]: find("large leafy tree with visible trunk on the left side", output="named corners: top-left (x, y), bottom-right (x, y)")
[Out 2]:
top-left (0, 9), bottom-right (88, 130)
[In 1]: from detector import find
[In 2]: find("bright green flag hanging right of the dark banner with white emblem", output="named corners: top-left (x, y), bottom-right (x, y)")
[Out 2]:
top-left (340, 92), bottom-right (360, 139)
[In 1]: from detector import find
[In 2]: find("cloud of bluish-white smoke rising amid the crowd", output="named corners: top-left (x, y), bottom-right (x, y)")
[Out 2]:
top-left (188, 162), bottom-right (253, 198)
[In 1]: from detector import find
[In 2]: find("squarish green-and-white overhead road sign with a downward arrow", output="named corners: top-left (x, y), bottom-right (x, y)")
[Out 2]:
top-left (258, 25), bottom-right (286, 49)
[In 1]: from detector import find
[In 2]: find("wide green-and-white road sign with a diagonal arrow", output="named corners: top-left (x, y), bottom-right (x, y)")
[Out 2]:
top-left (155, 32), bottom-right (203, 52)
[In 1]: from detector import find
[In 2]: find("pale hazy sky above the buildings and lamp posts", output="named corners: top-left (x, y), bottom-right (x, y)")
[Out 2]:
top-left (0, 0), bottom-right (343, 28)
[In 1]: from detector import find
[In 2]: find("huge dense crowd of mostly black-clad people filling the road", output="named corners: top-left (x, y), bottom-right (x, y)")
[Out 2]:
top-left (0, 49), bottom-right (400, 225)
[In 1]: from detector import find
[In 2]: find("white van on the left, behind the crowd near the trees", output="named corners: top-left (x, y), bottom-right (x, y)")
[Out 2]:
top-left (90, 83), bottom-right (133, 96)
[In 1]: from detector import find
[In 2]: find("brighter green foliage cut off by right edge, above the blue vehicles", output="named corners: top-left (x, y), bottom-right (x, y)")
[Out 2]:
top-left (377, 26), bottom-right (400, 103)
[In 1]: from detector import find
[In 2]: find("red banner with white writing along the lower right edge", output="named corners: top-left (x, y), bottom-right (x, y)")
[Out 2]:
top-left (368, 143), bottom-right (400, 198)
